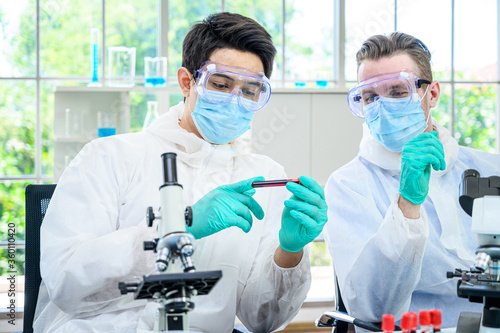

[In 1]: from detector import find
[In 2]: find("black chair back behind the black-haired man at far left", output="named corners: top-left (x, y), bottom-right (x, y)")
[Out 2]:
top-left (23, 184), bottom-right (56, 333)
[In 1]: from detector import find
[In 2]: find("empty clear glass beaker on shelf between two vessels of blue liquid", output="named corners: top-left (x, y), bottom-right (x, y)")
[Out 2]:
top-left (108, 46), bottom-right (135, 87)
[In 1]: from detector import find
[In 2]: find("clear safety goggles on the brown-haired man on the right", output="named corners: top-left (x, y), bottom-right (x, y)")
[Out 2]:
top-left (347, 70), bottom-right (431, 118)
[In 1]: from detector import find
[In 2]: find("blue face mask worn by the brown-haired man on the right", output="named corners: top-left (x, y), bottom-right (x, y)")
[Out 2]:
top-left (366, 97), bottom-right (430, 152)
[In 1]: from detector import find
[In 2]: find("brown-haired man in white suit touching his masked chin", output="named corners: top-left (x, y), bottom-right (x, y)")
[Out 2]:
top-left (325, 32), bottom-right (500, 327)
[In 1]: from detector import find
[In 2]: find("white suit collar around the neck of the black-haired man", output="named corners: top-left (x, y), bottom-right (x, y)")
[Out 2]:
top-left (146, 102), bottom-right (246, 169)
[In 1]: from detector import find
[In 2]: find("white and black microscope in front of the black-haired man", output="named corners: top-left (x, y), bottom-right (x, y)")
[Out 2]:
top-left (118, 153), bottom-right (222, 332)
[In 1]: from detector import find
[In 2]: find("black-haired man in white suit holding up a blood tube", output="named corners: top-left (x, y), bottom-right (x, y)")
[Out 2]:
top-left (35, 13), bottom-right (327, 333)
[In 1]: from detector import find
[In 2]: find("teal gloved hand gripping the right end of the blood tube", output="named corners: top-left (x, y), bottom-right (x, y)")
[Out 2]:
top-left (279, 176), bottom-right (328, 252)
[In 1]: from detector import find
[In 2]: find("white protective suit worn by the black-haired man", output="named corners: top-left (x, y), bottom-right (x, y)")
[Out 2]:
top-left (34, 103), bottom-right (311, 333)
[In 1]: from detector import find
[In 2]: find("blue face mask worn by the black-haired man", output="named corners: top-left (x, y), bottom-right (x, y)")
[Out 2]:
top-left (192, 92), bottom-right (254, 144)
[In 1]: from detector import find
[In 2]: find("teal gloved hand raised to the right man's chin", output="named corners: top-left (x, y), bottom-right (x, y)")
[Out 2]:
top-left (399, 131), bottom-right (446, 205)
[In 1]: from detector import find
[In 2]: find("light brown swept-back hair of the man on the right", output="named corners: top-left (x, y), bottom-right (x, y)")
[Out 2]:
top-left (356, 32), bottom-right (432, 81)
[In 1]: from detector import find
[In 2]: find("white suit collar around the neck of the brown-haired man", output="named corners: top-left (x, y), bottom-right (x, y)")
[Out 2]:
top-left (358, 117), bottom-right (458, 177)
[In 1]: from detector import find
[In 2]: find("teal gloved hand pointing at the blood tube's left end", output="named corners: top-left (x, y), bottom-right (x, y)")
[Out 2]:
top-left (186, 177), bottom-right (264, 239)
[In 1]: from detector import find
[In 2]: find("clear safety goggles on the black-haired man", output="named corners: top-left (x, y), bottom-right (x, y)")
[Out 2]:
top-left (196, 61), bottom-right (271, 111)
